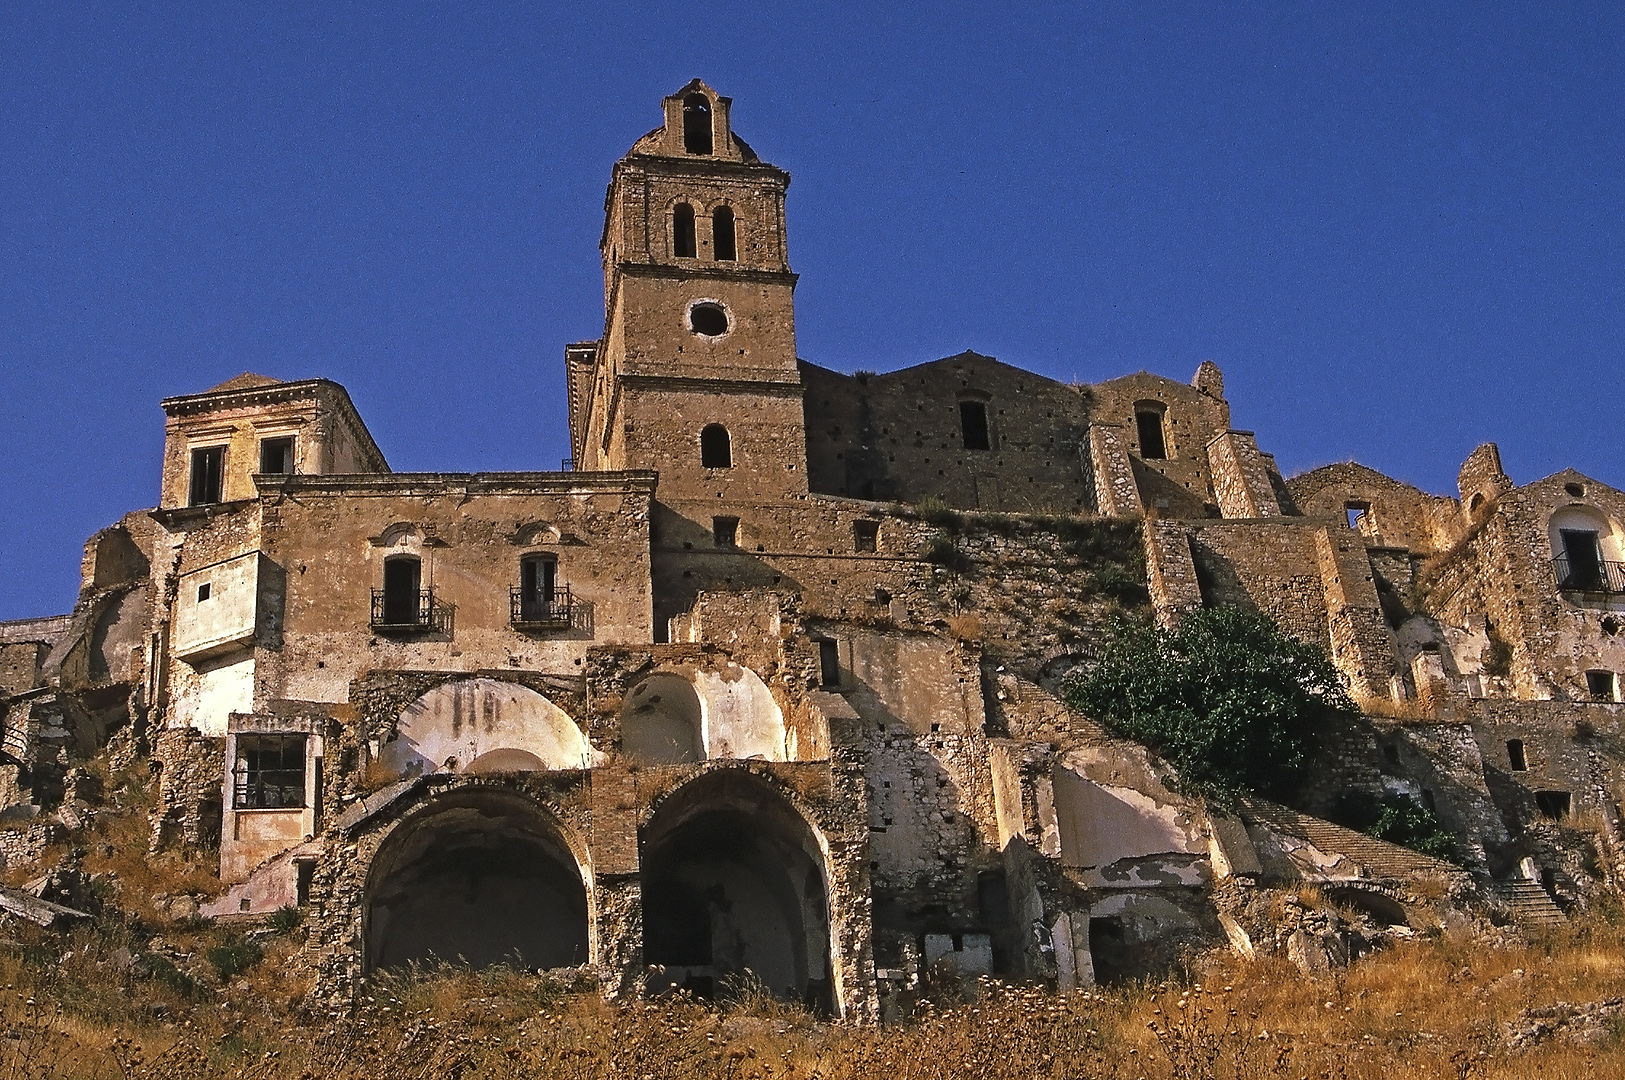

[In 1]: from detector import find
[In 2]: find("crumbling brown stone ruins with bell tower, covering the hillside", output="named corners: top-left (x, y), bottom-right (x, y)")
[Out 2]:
top-left (0, 81), bottom-right (1625, 1017)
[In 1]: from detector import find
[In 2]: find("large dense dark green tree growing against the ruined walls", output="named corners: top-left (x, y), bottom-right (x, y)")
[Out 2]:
top-left (1066, 606), bottom-right (1354, 799)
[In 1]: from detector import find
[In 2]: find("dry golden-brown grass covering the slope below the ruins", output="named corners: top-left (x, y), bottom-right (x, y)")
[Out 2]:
top-left (0, 918), bottom-right (1625, 1080)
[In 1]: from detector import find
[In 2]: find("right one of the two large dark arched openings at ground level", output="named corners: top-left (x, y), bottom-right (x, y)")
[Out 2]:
top-left (639, 770), bottom-right (834, 1010)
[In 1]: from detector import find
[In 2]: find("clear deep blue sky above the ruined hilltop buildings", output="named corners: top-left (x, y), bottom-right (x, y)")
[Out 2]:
top-left (0, 0), bottom-right (1625, 619)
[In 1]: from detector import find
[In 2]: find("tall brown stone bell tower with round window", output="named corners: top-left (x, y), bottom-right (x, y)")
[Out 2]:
top-left (566, 80), bottom-right (808, 506)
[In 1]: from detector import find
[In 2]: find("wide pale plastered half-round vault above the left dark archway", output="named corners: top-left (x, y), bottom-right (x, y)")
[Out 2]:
top-left (379, 679), bottom-right (598, 776)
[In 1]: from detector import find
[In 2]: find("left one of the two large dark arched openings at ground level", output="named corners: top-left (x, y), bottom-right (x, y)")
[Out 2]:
top-left (364, 788), bottom-right (592, 971)
